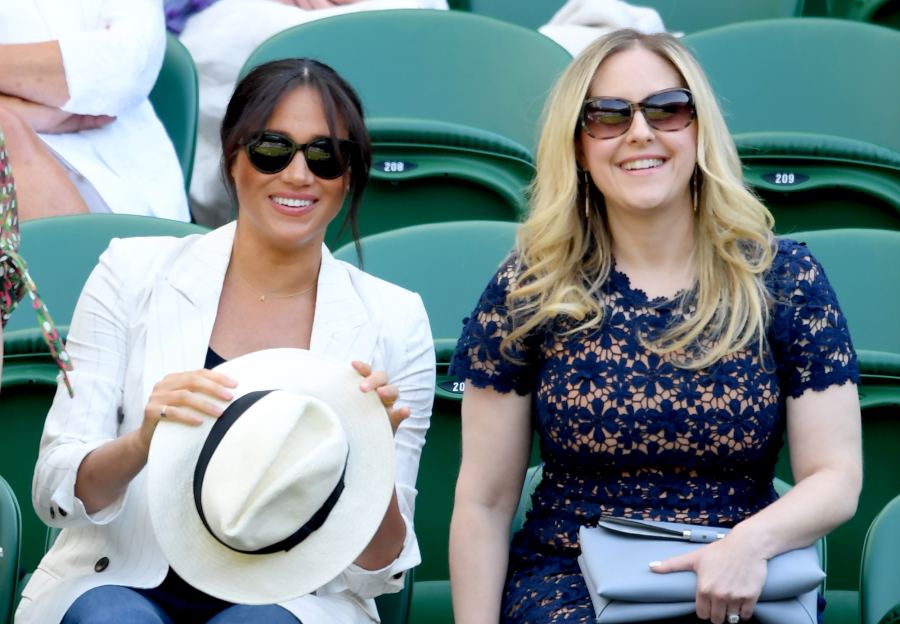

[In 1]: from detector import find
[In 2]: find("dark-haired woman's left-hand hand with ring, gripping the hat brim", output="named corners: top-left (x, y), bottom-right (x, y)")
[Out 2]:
top-left (141, 369), bottom-right (237, 448)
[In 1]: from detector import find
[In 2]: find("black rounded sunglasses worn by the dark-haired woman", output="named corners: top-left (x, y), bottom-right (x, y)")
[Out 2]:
top-left (245, 130), bottom-right (356, 180)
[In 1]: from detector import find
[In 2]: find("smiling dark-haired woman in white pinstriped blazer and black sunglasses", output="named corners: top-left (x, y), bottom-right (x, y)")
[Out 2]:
top-left (16, 59), bottom-right (435, 624)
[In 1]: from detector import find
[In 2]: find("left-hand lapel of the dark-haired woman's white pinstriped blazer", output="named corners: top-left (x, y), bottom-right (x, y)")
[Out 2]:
top-left (144, 222), bottom-right (235, 395)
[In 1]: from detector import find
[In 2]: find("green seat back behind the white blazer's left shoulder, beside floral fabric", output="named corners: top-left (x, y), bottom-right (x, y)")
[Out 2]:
top-left (4, 214), bottom-right (207, 333)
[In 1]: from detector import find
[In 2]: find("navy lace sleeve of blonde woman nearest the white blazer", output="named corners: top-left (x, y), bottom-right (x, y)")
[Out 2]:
top-left (450, 255), bottom-right (538, 396)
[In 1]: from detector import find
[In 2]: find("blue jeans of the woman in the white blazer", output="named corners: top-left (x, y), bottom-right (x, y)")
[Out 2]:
top-left (60, 585), bottom-right (299, 624)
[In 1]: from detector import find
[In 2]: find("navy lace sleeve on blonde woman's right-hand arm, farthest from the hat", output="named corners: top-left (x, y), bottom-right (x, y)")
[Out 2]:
top-left (768, 240), bottom-right (859, 398)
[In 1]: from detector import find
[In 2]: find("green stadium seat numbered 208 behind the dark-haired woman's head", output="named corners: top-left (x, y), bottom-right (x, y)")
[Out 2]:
top-left (242, 10), bottom-right (570, 248)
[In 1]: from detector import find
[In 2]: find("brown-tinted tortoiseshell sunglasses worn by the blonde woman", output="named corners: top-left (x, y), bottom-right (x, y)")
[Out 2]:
top-left (581, 89), bottom-right (697, 139)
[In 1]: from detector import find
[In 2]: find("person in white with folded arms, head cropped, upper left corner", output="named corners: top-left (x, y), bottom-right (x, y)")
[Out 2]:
top-left (0, 0), bottom-right (190, 221)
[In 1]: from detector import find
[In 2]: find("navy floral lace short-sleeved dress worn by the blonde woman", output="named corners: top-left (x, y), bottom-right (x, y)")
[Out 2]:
top-left (451, 240), bottom-right (858, 624)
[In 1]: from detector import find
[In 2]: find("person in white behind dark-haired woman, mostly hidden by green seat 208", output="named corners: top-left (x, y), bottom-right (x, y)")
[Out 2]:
top-left (181, 0), bottom-right (448, 227)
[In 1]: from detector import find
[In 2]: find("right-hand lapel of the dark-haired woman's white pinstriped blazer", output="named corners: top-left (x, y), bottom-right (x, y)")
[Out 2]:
top-left (310, 245), bottom-right (378, 363)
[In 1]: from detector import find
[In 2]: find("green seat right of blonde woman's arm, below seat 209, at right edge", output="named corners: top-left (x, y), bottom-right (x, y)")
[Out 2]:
top-left (777, 229), bottom-right (900, 604)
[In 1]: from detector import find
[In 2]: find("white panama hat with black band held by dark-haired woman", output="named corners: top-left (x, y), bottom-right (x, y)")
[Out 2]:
top-left (147, 349), bottom-right (394, 604)
